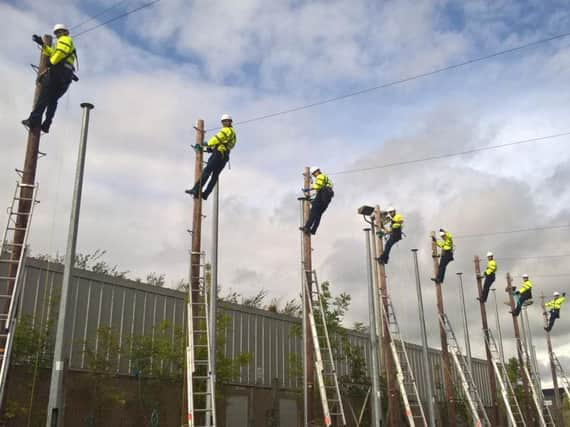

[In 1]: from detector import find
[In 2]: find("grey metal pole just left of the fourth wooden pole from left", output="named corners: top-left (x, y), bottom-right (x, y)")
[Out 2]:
top-left (364, 228), bottom-right (382, 427)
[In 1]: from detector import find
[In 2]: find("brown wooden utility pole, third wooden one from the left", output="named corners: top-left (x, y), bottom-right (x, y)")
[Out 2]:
top-left (302, 167), bottom-right (315, 426)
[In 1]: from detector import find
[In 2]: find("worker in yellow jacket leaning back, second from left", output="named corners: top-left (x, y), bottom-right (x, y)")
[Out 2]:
top-left (186, 114), bottom-right (237, 200)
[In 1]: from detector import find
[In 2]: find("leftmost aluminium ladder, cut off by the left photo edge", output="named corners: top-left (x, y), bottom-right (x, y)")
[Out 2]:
top-left (0, 182), bottom-right (39, 408)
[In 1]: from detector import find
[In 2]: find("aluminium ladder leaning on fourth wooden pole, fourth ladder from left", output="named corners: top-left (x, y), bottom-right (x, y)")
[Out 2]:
top-left (382, 297), bottom-right (428, 427)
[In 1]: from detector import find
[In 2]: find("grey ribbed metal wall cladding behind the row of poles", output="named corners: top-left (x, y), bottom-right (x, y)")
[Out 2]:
top-left (17, 259), bottom-right (491, 405)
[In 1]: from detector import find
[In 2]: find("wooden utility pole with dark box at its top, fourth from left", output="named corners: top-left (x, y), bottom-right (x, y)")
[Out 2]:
top-left (374, 206), bottom-right (400, 427)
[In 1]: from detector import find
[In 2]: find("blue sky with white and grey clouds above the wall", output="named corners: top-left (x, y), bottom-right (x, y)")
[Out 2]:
top-left (0, 0), bottom-right (570, 383)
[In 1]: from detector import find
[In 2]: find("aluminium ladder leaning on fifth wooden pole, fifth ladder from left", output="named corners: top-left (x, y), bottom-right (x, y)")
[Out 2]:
top-left (439, 313), bottom-right (491, 427)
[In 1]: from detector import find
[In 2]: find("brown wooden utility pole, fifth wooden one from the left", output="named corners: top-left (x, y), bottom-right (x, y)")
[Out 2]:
top-left (431, 231), bottom-right (457, 427)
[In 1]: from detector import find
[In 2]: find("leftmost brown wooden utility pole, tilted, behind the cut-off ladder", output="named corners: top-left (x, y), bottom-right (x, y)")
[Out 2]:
top-left (0, 31), bottom-right (52, 412)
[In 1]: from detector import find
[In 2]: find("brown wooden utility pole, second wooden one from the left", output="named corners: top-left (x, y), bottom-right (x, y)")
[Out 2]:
top-left (186, 119), bottom-right (206, 424)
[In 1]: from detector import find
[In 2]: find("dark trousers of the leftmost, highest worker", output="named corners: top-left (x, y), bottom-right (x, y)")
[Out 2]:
top-left (28, 65), bottom-right (73, 127)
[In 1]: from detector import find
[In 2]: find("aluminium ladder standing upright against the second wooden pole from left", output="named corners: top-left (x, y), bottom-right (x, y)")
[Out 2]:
top-left (186, 253), bottom-right (216, 427)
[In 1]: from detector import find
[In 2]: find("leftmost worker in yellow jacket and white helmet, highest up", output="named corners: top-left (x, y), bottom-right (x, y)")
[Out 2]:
top-left (22, 24), bottom-right (77, 133)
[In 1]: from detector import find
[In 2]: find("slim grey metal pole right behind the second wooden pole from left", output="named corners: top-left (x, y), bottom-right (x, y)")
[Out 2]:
top-left (207, 178), bottom-right (220, 425)
